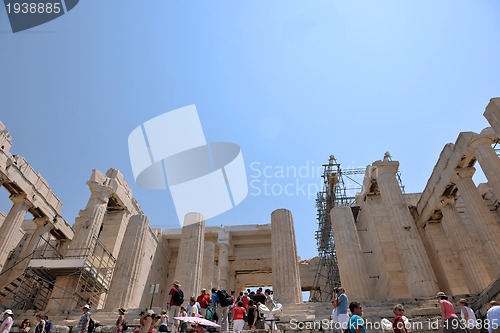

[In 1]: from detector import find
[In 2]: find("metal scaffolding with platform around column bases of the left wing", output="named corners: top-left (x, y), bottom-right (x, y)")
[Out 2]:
top-left (0, 233), bottom-right (115, 312)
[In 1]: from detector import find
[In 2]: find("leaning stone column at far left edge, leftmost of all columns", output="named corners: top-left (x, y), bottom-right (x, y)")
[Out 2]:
top-left (0, 194), bottom-right (31, 271)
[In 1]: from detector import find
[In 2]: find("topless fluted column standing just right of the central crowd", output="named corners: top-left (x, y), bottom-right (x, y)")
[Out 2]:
top-left (271, 209), bottom-right (302, 303)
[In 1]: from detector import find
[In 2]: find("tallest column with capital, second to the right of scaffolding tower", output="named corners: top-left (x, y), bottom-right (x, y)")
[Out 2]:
top-left (373, 161), bottom-right (438, 297)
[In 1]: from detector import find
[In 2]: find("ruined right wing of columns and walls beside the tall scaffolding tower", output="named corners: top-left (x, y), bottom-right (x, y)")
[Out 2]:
top-left (332, 98), bottom-right (500, 299)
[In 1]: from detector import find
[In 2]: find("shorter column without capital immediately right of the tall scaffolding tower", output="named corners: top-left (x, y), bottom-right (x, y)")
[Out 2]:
top-left (330, 206), bottom-right (370, 301)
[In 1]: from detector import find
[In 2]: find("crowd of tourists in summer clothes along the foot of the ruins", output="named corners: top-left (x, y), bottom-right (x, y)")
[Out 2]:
top-left (0, 281), bottom-right (500, 333)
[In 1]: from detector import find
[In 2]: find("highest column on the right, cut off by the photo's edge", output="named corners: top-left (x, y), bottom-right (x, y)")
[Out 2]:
top-left (474, 138), bottom-right (500, 200)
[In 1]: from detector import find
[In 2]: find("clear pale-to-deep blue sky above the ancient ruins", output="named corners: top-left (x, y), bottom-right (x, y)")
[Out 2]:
top-left (0, 0), bottom-right (500, 258)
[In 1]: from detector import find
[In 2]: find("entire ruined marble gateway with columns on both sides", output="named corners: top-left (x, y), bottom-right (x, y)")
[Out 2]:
top-left (0, 98), bottom-right (500, 315)
